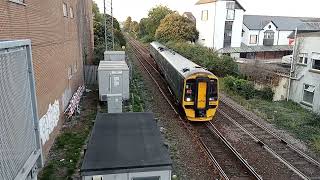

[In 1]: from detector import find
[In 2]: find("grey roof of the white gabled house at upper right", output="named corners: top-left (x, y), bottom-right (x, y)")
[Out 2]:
top-left (243, 15), bottom-right (320, 31)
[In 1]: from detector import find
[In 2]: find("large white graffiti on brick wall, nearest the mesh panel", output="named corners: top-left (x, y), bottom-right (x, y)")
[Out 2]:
top-left (39, 100), bottom-right (60, 144)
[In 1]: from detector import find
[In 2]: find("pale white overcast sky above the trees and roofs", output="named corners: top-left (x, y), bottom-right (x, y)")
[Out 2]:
top-left (94, 0), bottom-right (320, 21)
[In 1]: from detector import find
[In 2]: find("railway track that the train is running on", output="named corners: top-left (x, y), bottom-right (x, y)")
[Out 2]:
top-left (128, 37), bottom-right (262, 180)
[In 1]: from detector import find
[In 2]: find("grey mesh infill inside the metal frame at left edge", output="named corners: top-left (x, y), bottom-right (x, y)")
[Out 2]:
top-left (0, 44), bottom-right (37, 180)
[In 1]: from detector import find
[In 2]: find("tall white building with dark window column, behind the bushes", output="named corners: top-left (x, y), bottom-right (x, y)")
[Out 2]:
top-left (193, 0), bottom-right (245, 50)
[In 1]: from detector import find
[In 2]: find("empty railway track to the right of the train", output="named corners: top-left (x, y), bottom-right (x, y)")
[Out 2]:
top-left (218, 98), bottom-right (320, 179)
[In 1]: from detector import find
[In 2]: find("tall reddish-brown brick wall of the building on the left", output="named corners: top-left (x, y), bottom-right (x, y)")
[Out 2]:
top-left (0, 0), bottom-right (93, 158)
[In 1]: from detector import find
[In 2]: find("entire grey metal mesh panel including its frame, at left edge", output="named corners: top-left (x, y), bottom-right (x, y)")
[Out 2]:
top-left (0, 40), bottom-right (42, 180)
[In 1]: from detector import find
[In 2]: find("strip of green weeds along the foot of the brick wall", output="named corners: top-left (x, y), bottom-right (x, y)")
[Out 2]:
top-left (38, 93), bottom-right (97, 180)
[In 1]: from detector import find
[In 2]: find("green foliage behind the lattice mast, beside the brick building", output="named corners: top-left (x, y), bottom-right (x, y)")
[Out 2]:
top-left (92, 2), bottom-right (126, 64)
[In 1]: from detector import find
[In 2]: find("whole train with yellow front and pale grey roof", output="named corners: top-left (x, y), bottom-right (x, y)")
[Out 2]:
top-left (150, 42), bottom-right (219, 121)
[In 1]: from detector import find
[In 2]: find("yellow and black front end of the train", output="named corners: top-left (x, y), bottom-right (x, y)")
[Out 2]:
top-left (182, 74), bottom-right (219, 121)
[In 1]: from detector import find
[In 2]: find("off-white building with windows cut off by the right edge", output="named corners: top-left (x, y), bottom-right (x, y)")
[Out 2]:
top-left (289, 32), bottom-right (320, 113)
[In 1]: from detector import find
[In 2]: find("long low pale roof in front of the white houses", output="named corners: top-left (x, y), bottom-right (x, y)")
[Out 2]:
top-left (218, 43), bottom-right (292, 54)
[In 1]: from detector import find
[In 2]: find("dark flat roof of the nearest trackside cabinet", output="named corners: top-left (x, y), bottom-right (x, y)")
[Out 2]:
top-left (81, 113), bottom-right (172, 175)
